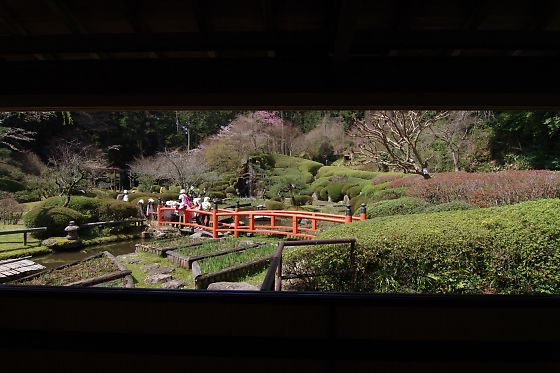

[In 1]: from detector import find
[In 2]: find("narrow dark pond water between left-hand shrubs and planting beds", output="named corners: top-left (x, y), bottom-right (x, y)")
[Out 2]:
top-left (33, 239), bottom-right (143, 268)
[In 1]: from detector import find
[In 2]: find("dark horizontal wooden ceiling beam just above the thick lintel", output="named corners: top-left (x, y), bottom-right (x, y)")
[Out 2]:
top-left (0, 29), bottom-right (560, 56)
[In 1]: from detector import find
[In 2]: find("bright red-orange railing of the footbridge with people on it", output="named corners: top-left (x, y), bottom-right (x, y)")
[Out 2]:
top-left (158, 204), bottom-right (366, 239)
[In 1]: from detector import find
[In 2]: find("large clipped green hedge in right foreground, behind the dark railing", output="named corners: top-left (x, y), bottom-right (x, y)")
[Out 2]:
top-left (284, 199), bottom-right (560, 295)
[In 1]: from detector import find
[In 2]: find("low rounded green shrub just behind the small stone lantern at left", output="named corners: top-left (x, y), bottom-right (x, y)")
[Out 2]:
top-left (23, 206), bottom-right (85, 238)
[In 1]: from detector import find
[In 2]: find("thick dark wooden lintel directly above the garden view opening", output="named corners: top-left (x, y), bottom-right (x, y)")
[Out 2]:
top-left (0, 56), bottom-right (560, 110)
